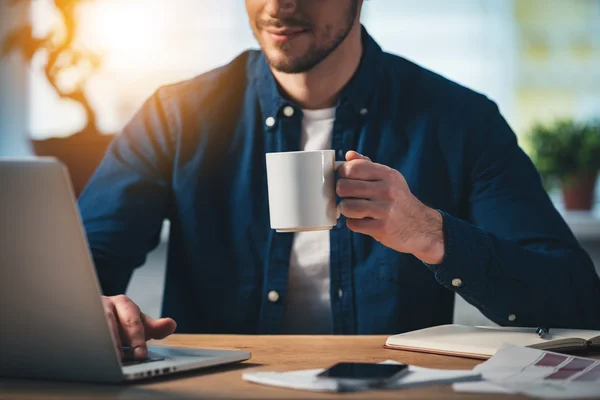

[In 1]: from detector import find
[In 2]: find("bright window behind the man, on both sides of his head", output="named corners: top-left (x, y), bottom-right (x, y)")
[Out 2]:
top-left (25, 0), bottom-right (513, 139)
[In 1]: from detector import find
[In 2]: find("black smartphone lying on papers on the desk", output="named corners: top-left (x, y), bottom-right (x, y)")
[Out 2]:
top-left (317, 362), bottom-right (408, 385)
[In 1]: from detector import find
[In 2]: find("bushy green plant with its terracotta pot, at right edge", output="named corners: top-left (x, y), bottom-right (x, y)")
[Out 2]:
top-left (528, 119), bottom-right (600, 210)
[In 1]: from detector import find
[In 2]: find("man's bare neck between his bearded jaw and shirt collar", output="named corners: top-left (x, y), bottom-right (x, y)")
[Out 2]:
top-left (273, 23), bottom-right (363, 110)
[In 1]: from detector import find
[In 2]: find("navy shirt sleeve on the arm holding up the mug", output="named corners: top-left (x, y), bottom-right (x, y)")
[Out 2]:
top-left (422, 101), bottom-right (600, 329)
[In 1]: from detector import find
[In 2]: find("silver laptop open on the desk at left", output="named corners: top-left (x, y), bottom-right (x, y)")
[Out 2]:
top-left (0, 158), bottom-right (250, 383)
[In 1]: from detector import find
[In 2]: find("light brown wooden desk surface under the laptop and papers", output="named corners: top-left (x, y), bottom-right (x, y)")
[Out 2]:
top-left (0, 335), bottom-right (580, 400)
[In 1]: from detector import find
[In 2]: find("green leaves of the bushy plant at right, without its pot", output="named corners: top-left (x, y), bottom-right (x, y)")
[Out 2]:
top-left (527, 119), bottom-right (600, 187)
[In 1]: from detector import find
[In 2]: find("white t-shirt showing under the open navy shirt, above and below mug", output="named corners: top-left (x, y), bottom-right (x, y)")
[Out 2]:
top-left (282, 107), bottom-right (335, 334)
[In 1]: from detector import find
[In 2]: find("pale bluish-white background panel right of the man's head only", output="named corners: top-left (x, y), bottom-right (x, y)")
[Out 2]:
top-left (363, 0), bottom-right (516, 122)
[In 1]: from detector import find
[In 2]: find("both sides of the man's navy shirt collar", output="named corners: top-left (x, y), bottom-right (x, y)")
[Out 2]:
top-left (248, 26), bottom-right (383, 122)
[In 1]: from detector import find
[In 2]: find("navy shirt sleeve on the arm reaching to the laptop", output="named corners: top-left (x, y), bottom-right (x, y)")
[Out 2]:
top-left (79, 90), bottom-right (173, 295)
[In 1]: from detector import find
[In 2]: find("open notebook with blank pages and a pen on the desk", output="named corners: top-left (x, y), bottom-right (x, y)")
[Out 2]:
top-left (385, 325), bottom-right (600, 359)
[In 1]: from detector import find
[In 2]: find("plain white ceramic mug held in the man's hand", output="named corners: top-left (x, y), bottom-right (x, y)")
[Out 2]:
top-left (266, 150), bottom-right (343, 232)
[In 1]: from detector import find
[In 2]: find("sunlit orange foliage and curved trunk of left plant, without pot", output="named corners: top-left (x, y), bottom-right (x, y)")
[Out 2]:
top-left (0, 0), bottom-right (101, 135)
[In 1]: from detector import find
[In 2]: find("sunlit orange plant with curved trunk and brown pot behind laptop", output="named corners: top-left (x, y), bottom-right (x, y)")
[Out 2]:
top-left (0, 0), bottom-right (114, 196)
